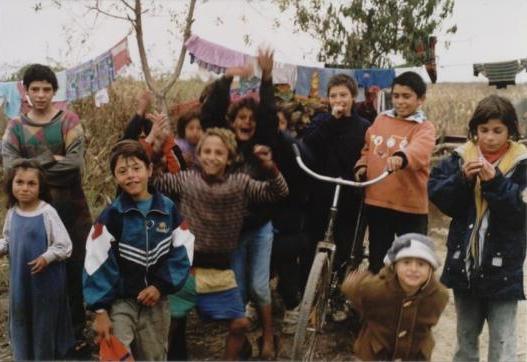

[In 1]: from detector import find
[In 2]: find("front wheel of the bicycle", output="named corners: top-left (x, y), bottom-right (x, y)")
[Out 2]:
top-left (292, 252), bottom-right (331, 361)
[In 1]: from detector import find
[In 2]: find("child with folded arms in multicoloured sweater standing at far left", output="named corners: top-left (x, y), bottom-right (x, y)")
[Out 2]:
top-left (2, 64), bottom-right (92, 350)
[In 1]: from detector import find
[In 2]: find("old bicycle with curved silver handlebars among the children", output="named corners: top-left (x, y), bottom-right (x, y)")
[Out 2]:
top-left (292, 145), bottom-right (390, 361)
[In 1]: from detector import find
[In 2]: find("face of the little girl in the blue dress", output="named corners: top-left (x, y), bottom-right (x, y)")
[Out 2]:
top-left (12, 168), bottom-right (40, 210)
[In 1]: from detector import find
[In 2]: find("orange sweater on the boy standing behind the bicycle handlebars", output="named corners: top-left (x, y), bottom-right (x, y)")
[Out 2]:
top-left (355, 112), bottom-right (435, 214)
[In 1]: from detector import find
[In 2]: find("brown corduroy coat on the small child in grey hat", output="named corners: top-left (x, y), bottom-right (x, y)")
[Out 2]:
top-left (342, 266), bottom-right (448, 361)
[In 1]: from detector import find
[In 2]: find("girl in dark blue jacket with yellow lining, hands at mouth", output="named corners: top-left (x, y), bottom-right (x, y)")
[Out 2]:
top-left (428, 95), bottom-right (527, 361)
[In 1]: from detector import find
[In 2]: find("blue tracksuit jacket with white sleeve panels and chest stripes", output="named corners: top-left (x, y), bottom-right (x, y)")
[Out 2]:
top-left (83, 192), bottom-right (194, 310)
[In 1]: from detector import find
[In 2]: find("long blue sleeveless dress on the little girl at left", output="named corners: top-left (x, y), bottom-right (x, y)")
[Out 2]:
top-left (9, 211), bottom-right (75, 361)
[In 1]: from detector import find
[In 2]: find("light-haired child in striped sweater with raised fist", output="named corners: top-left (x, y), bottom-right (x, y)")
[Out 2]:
top-left (154, 128), bottom-right (288, 360)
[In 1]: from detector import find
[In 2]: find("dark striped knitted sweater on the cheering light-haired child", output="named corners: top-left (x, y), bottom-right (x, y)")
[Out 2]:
top-left (154, 170), bottom-right (289, 268)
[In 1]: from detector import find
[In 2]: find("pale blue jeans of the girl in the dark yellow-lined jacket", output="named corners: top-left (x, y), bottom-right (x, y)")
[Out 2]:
top-left (454, 291), bottom-right (518, 362)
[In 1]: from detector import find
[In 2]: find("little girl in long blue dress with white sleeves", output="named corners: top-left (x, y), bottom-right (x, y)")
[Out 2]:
top-left (0, 160), bottom-right (75, 361)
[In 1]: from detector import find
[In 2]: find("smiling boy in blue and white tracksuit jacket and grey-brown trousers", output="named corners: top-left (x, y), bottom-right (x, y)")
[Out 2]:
top-left (83, 140), bottom-right (194, 360)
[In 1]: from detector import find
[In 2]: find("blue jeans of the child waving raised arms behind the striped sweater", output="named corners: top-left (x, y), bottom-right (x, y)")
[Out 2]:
top-left (232, 222), bottom-right (273, 306)
